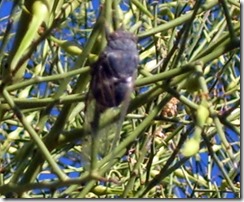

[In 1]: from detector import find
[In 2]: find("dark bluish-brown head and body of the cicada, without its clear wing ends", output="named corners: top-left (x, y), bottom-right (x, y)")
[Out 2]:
top-left (91, 30), bottom-right (139, 111)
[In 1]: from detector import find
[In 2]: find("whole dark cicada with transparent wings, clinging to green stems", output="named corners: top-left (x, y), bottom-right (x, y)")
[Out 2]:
top-left (82, 30), bottom-right (138, 170)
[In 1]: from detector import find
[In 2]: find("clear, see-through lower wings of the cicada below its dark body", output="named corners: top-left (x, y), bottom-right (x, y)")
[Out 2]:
top-left (82, 94), bottom-right (122, 165)
